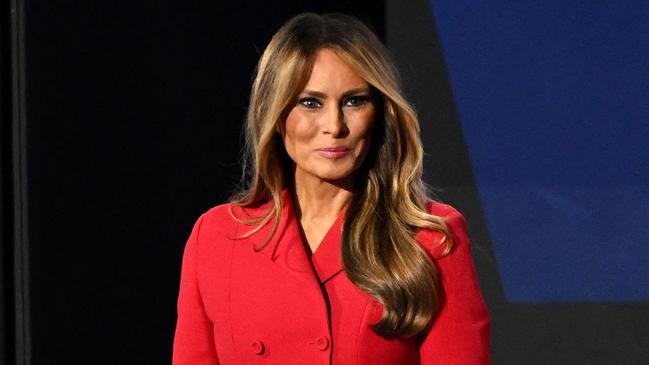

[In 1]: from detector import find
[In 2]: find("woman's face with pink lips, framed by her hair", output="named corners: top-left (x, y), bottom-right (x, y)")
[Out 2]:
top-left (283, 48), bottom-right (376, 182)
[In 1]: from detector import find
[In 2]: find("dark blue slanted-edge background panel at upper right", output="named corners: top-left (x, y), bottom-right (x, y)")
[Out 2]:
top-left (431, 0), bottom-right (649, 302)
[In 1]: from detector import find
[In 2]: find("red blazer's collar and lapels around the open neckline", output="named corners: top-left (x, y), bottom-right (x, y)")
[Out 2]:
top-left (243, 188), bottom-right (347, 283)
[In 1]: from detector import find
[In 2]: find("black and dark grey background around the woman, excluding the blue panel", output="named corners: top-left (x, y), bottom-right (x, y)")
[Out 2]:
top-left (0, 0), bottom-right (649, 365)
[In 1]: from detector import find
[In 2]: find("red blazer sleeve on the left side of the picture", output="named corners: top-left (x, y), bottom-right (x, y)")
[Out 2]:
top-left (173, 215), bottom-right (219, 365)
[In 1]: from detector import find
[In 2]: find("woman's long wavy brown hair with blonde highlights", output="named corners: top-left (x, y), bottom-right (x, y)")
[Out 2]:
top-left (232, 13), bottom-right (451, 338)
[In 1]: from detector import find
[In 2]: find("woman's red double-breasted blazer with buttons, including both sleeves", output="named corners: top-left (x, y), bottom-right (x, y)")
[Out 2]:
top-left (173, 189), bottom-right (490, 365)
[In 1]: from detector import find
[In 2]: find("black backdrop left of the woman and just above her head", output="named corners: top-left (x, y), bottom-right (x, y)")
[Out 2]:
top-left (2, 0), bottom-right (385, 364)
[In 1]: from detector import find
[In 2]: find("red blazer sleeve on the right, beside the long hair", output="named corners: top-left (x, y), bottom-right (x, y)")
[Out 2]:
top-left (420, 211), bottom-right (491, 365)
